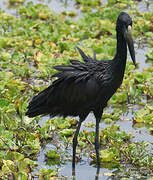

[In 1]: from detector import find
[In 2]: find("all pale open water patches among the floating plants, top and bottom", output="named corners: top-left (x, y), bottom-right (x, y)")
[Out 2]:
top-left (0, 0), bottom-right (153, 180)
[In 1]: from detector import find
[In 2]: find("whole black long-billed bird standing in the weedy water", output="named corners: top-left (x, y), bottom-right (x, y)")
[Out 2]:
top-left (26, 12), bottom-right (136, 169)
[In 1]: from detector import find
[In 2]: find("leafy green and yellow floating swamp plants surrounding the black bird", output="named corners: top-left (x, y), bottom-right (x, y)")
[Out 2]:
top-left (0, 0), bottom-right (153, 180)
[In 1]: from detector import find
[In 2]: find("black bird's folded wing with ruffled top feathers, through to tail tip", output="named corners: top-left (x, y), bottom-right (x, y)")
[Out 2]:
top-left (27, 49), bottom-right (108, 117)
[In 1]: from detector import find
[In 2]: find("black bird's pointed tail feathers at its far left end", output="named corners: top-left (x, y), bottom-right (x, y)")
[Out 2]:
top-left (26, 87), bottom-right (50, 117)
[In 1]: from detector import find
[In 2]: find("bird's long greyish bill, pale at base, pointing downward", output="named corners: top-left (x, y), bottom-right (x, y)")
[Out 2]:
top-left (124, 25), bottom-right (136, 66)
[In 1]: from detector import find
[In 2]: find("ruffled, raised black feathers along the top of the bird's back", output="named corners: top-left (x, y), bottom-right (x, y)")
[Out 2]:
top-left (52, 47), bottom-right (106, 84)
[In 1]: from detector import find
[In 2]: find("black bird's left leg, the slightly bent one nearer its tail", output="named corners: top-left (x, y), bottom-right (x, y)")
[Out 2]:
top-left (72, 119), bottom-right (84, 171)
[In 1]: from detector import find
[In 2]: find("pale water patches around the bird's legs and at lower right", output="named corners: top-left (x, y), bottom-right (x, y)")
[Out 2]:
top-left (37, 105), bottom-right (152, 180)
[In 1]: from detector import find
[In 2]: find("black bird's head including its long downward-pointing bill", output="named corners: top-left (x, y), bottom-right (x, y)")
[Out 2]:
top-left (116, 12), bottom-right (136, 66)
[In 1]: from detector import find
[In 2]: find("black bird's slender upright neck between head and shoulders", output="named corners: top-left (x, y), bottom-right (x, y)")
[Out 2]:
top-left (114, 32), bottom-right (127, 69)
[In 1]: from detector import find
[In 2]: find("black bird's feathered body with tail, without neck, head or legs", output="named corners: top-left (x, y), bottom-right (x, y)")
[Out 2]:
top-left (28, 49), bottom-right (124, 117)
